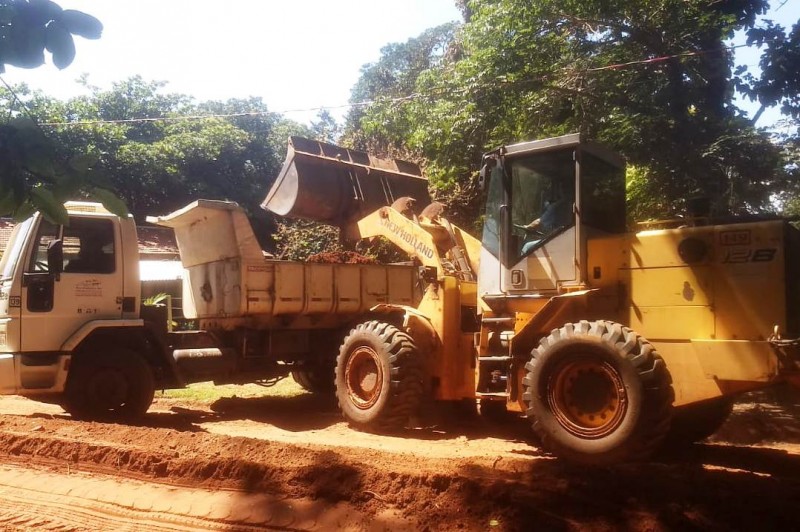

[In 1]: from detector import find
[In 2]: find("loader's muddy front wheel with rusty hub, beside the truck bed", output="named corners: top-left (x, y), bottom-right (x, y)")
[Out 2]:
top-left (336, 321), bottom-right (423, 430)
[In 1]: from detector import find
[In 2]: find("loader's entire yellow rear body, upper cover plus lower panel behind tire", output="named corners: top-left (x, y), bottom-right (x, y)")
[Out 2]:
top-left (576, 218), bottom-right (787, 406)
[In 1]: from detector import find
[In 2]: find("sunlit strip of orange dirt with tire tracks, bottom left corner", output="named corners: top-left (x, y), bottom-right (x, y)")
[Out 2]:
top-left (0, 466), bottom-right (332, 532)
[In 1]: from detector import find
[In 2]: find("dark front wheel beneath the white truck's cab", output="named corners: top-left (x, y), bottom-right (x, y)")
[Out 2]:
top-left (64, 349), bottom-right (155, 421)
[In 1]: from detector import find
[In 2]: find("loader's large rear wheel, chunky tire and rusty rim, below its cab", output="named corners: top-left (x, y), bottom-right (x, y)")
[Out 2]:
top-left (523, 321), bottom-right (674, 465)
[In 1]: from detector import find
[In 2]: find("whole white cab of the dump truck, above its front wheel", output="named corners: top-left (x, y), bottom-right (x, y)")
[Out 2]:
top-left (0, 202), bottom-right (141, 395)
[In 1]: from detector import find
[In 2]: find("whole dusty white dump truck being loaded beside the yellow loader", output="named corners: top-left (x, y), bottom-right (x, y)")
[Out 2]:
top-left (0, 139), bottom-right (427, 419)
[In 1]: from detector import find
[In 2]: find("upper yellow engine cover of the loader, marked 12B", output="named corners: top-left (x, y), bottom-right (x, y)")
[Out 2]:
top-left (587, 222), bottom-right (786, 341)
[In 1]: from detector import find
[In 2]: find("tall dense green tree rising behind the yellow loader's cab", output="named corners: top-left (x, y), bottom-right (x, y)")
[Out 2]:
top-left (353, 0), bottom-right (800, 224)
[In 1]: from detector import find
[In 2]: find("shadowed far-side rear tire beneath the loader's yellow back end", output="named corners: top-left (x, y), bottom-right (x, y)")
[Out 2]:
top-left (662, 397), bottom-right (735, 451)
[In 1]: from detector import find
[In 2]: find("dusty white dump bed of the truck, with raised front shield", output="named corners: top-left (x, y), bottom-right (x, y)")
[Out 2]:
top-left (148, 200), bottom-right (420, 328)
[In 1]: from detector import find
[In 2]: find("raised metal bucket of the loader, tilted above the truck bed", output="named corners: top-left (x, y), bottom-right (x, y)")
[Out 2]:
top-left (261, 137), bottom-right (430, 227)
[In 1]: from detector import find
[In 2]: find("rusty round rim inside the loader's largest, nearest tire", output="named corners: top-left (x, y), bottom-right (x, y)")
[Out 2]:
top-left (547, 357), bottom-right (628, 438)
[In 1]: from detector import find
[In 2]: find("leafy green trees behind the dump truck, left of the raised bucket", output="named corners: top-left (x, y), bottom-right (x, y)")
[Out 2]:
top-left (0, 77), bottom-right (310, 246)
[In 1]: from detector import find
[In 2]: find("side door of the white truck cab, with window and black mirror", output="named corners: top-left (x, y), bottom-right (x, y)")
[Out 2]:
top-left (21, 215), bottom-right (123, 353)
